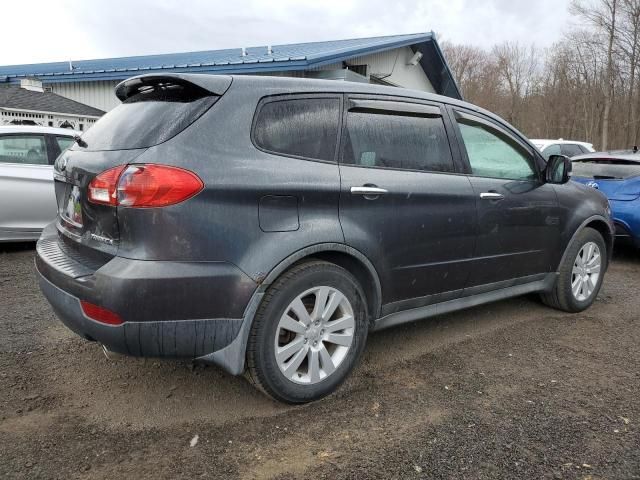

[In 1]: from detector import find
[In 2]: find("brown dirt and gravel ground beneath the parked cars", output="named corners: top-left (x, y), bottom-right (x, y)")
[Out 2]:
top-left (0, 245), bottom-right (640, 479)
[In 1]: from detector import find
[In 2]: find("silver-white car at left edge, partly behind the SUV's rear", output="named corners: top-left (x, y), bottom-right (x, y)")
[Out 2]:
top-left (0, 126), bottom-right (80, 242)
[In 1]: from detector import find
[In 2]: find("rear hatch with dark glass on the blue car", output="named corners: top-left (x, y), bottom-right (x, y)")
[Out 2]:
top-left (572, 158), bottom-right (640, 201)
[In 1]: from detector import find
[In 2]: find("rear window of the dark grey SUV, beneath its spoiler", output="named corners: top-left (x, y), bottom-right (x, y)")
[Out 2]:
top-left (82, 82), bottom-right (219, 150)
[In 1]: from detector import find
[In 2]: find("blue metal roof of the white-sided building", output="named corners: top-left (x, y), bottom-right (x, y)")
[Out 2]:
top-left (0, 32), bottom-right (461, 98)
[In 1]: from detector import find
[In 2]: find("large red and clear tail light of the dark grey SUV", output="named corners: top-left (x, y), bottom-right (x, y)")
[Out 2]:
top-left (89, 164), bottom-right (204, 208)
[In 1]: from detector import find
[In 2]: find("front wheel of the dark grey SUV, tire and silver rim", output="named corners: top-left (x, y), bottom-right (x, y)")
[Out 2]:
top-left (541, 227), bottom-right (609, 313)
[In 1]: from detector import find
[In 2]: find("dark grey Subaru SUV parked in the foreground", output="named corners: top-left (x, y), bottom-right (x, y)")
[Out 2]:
top-left (36, 74), bottom-right (613, 403)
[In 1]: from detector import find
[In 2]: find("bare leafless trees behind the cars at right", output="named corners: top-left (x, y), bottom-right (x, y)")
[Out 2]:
top-left (443, 0), bottom-right (640, 150)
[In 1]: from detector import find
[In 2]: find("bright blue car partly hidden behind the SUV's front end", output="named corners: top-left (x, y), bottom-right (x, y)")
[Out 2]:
top-left (571, 151), bottom-right (640, 248)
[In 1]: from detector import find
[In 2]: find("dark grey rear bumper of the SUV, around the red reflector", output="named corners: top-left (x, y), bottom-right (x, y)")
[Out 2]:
top-left (36, 223), bottom-right (257, 358)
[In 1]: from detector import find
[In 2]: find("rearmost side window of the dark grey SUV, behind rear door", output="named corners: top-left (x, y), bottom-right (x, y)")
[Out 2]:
top-left (253, 98), bottom-right (340, 161)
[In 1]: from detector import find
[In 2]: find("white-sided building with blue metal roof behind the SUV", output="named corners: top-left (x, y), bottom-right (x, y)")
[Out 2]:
top-left (0, 33), bottom-right (461, 111)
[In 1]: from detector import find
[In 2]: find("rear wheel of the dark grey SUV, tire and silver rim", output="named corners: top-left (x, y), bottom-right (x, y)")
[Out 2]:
top-left (247, 261), bottom-right (369, 404)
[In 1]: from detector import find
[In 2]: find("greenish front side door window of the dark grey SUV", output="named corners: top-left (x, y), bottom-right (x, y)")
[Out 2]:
top-left (458, 119), bottom-right (537, 180)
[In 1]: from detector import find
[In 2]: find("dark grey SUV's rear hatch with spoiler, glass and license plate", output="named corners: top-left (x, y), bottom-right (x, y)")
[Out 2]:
top-left (54, 75), bottom-right (231, 258)
